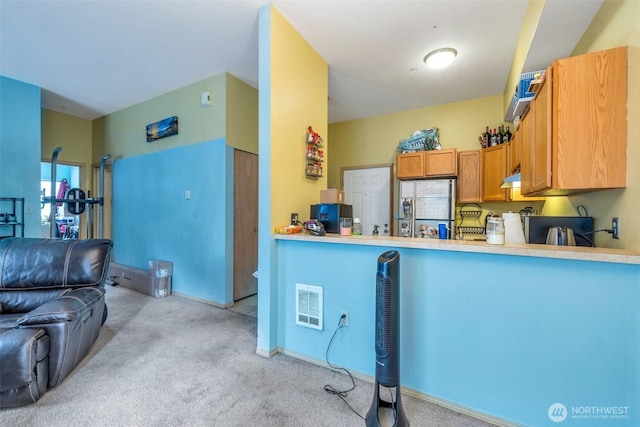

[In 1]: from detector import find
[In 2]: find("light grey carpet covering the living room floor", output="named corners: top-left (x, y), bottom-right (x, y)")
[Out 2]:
top-left (0, 286), bottom-right (500, 427)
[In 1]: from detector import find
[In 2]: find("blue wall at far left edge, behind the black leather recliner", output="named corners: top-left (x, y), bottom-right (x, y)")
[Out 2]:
top-left (0, 76), bottom-right (41, 237)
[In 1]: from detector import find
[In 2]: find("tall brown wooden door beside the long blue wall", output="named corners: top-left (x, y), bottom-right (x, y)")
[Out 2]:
top-left (233, 150), bottom-right (258, 301)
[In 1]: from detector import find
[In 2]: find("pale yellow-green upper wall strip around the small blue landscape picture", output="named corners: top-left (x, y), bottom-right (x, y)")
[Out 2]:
top-left (94, 73), bottom-right (227, 160)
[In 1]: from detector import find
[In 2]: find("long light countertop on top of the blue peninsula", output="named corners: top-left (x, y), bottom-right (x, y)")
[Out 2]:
top-left (274, 233), bottom-right (640, 265)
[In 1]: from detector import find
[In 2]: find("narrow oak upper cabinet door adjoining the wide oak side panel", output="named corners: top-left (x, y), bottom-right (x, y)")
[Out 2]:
top-left (531, 69), bottom-right (552, 192)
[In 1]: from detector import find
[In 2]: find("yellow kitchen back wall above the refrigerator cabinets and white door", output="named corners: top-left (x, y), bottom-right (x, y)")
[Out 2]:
top-left (328, 95), bottom-right (510, 188)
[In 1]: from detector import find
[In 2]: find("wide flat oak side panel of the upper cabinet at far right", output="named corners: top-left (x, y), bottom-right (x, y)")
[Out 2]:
top-left (552, 47), bottom-right (637, 191)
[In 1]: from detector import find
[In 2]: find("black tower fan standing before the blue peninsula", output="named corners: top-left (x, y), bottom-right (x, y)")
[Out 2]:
top-left (365, 251), bottom-right (409, 427)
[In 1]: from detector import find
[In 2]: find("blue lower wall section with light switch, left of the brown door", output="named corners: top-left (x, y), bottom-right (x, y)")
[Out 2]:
top-left (113, 138), bottom-right (234, 305)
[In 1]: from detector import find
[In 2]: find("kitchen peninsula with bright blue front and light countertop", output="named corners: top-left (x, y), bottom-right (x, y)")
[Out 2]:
top-left (275, 235), bottom-right (640, 426)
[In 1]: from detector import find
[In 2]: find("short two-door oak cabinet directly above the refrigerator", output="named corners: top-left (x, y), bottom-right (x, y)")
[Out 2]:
top-left (396, 148), bottom-right (458, 179)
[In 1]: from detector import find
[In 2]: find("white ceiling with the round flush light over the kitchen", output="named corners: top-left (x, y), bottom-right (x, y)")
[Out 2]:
top-left (0, 0), bottom-right (602, 123)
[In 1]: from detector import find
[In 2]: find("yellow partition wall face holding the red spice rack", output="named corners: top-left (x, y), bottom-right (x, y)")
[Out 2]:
top-left (270, 8), bottom-right (336, 229)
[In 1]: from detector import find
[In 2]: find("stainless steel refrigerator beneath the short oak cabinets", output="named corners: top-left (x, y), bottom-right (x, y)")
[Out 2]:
top-left (396, 179), bottom-right (456, 239)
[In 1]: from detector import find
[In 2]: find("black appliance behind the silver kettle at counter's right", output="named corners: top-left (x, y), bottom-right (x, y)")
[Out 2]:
top-left (522, 215), bottom-right (593, 246)
